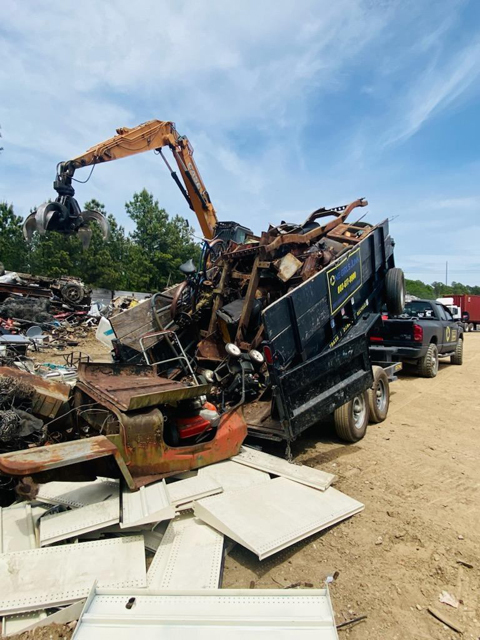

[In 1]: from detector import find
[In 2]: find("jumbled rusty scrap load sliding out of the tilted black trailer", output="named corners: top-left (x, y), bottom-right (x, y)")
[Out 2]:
top-left (111, 199), bottom-right (373, 410)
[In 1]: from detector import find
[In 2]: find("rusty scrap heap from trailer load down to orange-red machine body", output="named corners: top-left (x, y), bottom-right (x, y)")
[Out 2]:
top-left (0, 199), bottom-right (386, 493)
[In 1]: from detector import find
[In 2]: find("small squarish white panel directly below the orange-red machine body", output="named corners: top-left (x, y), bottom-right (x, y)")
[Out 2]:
top-left (120, 480), bottom-right (175, 529)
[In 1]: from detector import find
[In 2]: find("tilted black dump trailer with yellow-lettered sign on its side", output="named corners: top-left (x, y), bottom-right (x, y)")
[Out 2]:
top-left (251, 220), bottom-right (405, 442)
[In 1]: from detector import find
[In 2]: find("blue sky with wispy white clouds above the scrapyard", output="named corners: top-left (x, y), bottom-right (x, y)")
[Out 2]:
top-left (0, 0), bottom-right (480, 284)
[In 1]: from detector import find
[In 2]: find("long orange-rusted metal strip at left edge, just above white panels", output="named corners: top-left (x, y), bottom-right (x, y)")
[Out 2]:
top-left (0, 436), bottom-right (117, 476)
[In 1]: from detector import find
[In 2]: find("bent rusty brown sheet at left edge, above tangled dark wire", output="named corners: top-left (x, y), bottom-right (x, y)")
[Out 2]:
top-left (0, 367), bottom-right (71, 418)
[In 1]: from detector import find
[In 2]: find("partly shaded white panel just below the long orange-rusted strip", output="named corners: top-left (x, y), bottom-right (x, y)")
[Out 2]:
top-left (36, 478), bottom-right (120, 508)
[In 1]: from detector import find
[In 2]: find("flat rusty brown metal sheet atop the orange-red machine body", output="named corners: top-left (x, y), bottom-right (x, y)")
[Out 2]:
top-left (77, 362), bottom-right (211, 411)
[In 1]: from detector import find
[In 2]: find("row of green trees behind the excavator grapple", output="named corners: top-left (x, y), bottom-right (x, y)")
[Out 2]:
top-left (0, 189), bottom-right (200, 291)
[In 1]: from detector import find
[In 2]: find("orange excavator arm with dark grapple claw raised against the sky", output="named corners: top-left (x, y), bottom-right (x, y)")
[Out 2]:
top-left (24, 120), bottom-right (218, 246)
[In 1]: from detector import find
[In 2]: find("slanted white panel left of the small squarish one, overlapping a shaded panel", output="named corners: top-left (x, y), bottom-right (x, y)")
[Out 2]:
top-left (40, 493), bottom-right (120, 547)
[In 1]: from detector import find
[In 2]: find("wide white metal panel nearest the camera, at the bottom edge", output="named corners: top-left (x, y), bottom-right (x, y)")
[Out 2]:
top-left (73, 589), bottom-right (338, 640)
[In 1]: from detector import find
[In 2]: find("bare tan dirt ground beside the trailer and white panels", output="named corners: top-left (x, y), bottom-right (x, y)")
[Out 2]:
top-left (4, 332), bottom-right (480, 640)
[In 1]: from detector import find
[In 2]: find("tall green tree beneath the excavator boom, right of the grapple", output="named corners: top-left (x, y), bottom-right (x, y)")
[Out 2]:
top-left (125, 189), bottom-right (200, 291)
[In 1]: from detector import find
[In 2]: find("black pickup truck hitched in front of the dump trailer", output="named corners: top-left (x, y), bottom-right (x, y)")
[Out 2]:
top-left (370, 300), bottom-right (463, 378)
